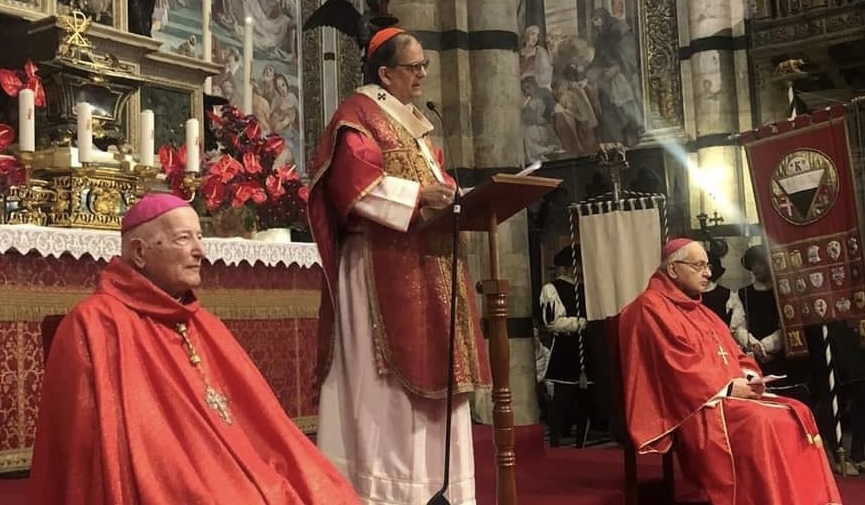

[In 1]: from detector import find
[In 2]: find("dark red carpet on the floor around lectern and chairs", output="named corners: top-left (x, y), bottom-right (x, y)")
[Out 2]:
top-left (0, 426), bottom-right (865, 505)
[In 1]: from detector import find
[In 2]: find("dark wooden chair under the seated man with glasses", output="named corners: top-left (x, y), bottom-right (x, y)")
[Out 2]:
top-left (604, 315), bottom-right (675, 505)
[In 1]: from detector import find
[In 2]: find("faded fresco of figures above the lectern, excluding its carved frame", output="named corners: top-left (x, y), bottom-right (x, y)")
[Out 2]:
top-left (519, 0), bottom-right (645, 162)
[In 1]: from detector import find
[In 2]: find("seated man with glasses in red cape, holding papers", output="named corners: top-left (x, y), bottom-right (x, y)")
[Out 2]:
top-left (619, 239), bottom-right (841, 505)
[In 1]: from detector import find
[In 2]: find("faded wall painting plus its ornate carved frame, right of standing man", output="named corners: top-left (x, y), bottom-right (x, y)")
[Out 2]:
top-left (519, 0), bottom-right (683, 162)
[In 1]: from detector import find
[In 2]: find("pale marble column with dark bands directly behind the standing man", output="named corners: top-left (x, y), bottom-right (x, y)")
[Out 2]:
top-left (390, 0), bottom-right (538, 424)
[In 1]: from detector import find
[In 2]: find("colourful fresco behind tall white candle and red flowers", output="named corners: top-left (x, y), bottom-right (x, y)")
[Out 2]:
top-left (152, 0), bottom-right (305, 173)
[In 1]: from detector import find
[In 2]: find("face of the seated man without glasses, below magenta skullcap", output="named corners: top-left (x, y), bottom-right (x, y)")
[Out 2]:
top-left (136, 207), bottom-right (205, 296)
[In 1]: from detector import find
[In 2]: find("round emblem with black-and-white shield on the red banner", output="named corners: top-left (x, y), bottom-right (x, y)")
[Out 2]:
top-left (772, 149), bottom-right (838, 225)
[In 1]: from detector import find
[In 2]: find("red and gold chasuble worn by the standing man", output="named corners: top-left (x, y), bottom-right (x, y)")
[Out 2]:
top-left (309, 93), bottom-right (490, 399)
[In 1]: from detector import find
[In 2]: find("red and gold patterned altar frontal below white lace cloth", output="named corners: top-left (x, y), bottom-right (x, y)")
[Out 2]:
top-left (0, 251), bottom-right (321, 473)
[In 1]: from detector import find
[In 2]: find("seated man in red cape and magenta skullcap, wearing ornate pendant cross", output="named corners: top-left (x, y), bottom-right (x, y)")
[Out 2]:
top-left (30, 194), bottom-right (360, 505)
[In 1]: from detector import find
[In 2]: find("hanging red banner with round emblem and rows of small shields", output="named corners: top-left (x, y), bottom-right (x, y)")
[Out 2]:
top-left (740, 106), bottom-right (865, 355)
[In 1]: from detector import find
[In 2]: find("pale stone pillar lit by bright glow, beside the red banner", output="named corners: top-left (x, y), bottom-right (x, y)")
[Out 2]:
top-left (680, 0), bottom-right (757, 228)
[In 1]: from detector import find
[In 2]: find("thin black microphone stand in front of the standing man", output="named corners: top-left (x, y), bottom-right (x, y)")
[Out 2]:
top-left (426, 102), bottom-right (462, 505)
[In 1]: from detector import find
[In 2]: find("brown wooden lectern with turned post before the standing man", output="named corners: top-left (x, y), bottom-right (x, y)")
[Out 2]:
top-left (425, 174), bottom-right (562, 505)
